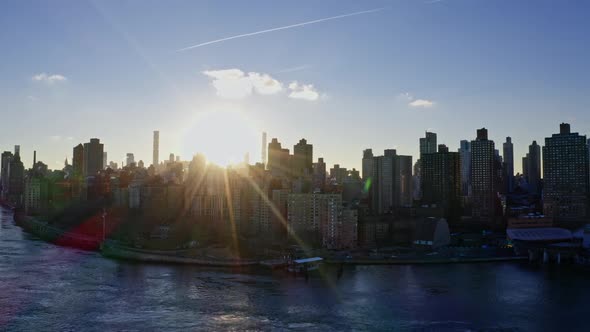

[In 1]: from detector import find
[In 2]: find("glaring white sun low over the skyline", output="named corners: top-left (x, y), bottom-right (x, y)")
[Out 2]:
top-left (182, 107), bottom-right (260, 166)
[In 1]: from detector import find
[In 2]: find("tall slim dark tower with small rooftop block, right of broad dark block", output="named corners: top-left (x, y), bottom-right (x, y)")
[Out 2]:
top-left (471, 128), bottom-right (497, 222)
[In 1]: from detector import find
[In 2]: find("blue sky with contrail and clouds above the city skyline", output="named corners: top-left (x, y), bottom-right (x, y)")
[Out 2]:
top-left (0, 0), bottom-right (590, 171)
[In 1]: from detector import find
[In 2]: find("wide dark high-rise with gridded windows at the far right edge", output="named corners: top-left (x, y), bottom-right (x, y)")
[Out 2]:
top-left (543, 123), bottom-right (589, 221)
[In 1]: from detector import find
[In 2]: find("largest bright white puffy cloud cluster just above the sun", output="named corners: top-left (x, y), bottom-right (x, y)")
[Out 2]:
top-left (203, 68), bottom-right (320, 101)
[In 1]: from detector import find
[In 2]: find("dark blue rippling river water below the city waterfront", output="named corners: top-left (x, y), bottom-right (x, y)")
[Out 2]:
top-left (0, 210), bottom-right (590, 331)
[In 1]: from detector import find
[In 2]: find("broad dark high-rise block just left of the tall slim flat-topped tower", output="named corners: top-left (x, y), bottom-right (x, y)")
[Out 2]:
top-left (422, 144), bottom-right (461, 211)
